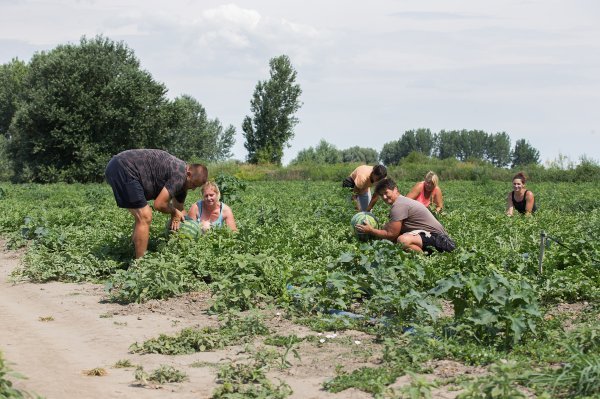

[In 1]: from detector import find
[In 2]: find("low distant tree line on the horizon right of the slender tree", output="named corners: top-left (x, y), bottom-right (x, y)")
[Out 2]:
top-left (292, 129), bottom-right (540, 168)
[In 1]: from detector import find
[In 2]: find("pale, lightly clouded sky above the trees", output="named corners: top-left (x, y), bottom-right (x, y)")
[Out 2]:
top-left (0, 0), bottom-right (600, 163)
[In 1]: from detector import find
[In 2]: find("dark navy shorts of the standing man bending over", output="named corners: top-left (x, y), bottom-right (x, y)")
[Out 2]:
top-left (105, 158), bottom-right (148, 209)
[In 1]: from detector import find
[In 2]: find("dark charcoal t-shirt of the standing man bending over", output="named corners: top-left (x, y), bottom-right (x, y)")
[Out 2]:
top-left (115, 149), bottom-right (187, 203)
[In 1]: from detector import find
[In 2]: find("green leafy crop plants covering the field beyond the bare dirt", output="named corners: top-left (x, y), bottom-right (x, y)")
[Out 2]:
top-left (0, 179), bottom-right (600, 397)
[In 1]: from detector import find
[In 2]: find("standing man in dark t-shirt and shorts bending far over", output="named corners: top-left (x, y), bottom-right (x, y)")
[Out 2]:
top-left (105, 149), bottom-right (208, 258)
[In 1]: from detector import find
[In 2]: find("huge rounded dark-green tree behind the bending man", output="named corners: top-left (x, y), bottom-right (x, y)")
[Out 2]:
top-left (9, 36), bottom-right (169, 182)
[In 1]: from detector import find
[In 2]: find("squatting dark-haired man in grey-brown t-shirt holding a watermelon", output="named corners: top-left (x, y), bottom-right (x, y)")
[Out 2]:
top-left (355, 178), bottom-right (456, 252)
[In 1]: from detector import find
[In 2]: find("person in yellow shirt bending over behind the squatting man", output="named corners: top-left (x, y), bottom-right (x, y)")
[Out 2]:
top-left (342, 165), bottom-right (387, 212)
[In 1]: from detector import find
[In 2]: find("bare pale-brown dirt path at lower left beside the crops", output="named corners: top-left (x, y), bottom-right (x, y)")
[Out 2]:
top-left (0, 242), bottom-right (371, 399)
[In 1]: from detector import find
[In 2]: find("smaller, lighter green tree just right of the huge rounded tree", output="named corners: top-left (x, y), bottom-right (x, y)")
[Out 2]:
top-left (165, 95), bottom-right (235, 161)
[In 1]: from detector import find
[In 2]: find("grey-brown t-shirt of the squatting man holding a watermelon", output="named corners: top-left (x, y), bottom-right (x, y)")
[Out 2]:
top-left (390, 195), bottom-right (448, 235)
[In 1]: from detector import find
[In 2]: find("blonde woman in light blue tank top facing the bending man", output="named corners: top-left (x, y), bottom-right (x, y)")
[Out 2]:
top-left (188, 181), bottom-right (237, 231)
